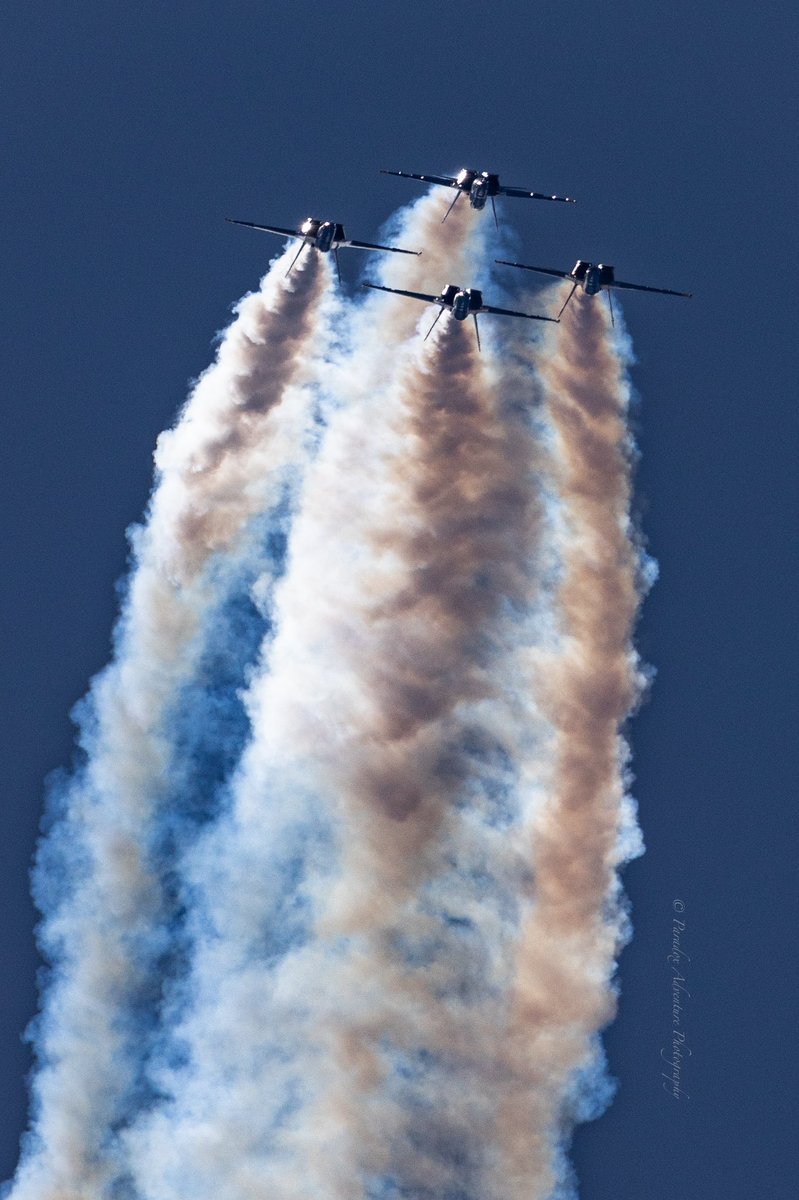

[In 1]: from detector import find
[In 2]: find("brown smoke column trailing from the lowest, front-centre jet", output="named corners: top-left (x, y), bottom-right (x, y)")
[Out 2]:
top-left (304, 323), bottom-right (541, 1198)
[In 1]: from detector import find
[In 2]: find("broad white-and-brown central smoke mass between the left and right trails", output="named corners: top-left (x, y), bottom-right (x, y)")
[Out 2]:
top-left (122, 200), bottom-right (559, 1200)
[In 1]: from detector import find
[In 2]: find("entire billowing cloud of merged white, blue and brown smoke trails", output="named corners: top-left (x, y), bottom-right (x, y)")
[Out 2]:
top-left (6, 196), bottom-right (641, 1200)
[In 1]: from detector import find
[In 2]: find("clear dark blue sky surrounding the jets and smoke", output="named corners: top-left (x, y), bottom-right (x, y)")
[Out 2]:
top-left (0, 0), bottom-right (799, 1200)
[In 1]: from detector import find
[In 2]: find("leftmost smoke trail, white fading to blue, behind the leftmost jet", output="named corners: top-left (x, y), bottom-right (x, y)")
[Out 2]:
top-left (12, 246), bottom-right (331, 1200)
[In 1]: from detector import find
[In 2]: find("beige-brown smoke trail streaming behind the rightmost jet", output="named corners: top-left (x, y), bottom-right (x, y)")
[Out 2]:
top-left (498, 295), bottom-right (642, 1200)
